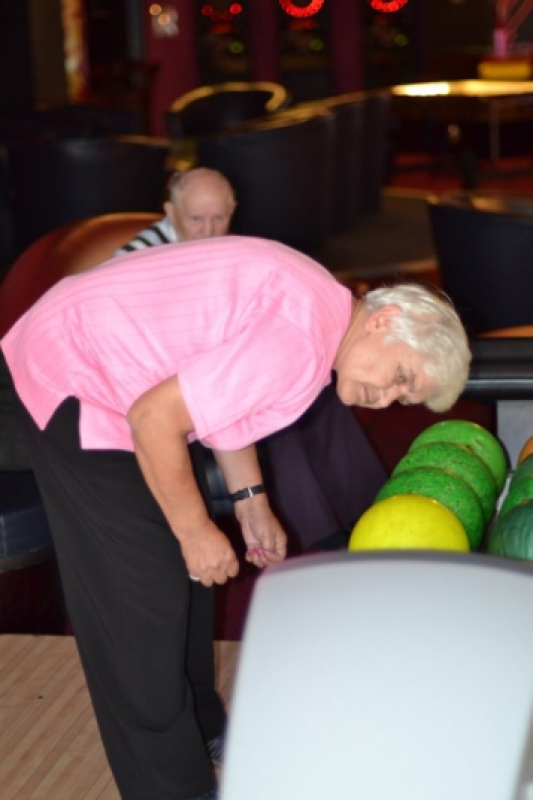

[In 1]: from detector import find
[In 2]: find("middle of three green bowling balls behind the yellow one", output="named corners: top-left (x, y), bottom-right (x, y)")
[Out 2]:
top-left (392, 442), bottom-right (497, 524)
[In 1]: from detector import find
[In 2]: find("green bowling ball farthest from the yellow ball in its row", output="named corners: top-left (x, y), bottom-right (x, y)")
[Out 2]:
top-left (409, 419), bottom-right (508, 494)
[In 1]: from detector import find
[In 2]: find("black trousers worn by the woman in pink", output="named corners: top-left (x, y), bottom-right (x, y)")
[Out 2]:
top-left (17, 398), bottom-right (225, 800)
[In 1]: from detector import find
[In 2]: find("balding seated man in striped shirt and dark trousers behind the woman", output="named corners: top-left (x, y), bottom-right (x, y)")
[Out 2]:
top-left (115, 167), bottom-right (387, 553)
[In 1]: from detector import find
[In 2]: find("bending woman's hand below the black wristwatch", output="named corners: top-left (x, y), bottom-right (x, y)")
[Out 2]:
top-left (235, 494), bottom-right (287, 568)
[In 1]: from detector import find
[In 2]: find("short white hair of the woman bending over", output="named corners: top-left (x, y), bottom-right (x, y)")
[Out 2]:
top-left (364, 283), bottom-right (472, 411)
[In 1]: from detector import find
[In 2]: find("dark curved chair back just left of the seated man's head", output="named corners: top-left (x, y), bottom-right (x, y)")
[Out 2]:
top-left (4, 136), bottom-right (170, 255)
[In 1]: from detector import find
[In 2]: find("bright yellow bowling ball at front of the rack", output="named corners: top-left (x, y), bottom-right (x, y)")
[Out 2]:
top-left (348, 494), bottom-right (470, 553)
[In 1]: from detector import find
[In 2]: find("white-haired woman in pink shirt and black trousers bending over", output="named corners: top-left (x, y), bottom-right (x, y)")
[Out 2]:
top-left (2, 236), bottom-right (470, 800)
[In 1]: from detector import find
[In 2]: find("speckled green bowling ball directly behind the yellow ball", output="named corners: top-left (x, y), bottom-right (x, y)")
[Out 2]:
top-left (376, 467), bottom-right (485, 549)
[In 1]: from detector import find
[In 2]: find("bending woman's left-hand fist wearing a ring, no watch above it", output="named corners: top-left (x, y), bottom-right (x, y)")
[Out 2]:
top-left (180, 520), bottom-right (239, 586)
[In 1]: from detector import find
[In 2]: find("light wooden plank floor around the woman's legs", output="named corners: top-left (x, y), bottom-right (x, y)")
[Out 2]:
top-left (0, 634), bottom-right (239, 800)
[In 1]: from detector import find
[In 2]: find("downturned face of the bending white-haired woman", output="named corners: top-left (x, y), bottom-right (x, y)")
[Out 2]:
top-left (337, 318), bottom-right (434, 408)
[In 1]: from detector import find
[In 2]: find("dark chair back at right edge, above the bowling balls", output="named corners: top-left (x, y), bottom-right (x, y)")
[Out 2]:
top-left (428, 191), bottom-right (533, 335)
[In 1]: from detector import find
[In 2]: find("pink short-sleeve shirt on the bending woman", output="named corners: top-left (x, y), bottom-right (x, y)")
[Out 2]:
top-left (2, 236), bottom-right (351, 450)
